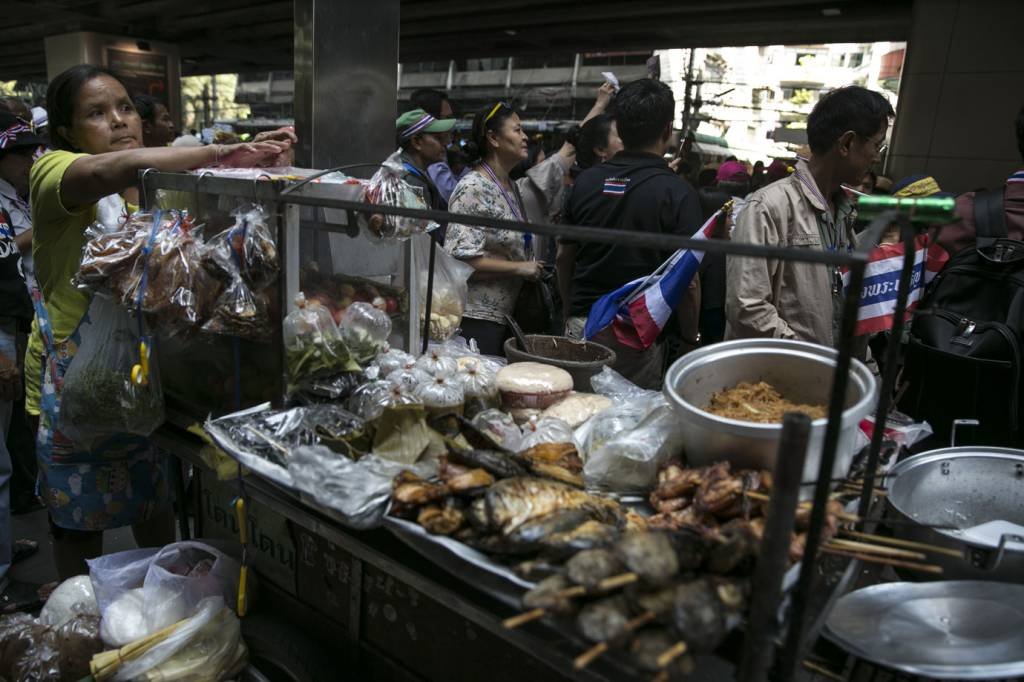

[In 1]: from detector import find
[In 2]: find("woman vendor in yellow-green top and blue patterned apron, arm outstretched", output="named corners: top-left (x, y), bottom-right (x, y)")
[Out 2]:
top-left (26, 65), bottom-right (295, 580)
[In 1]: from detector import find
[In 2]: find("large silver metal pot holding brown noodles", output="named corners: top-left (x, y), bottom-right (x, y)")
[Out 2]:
top-left (665, 339), bottom-right (876, 485)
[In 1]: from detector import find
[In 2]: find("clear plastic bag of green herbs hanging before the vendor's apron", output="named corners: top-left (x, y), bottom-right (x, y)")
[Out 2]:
top-left (59, 295), bottom-right (164, 450)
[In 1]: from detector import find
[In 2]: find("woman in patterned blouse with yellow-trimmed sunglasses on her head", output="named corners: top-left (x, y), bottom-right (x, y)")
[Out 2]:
top-left (444, 86), bottom-right (611, 355)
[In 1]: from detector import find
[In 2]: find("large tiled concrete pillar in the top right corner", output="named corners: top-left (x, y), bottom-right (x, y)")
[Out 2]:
top-left (887, 0), bottom-right (1024, 194)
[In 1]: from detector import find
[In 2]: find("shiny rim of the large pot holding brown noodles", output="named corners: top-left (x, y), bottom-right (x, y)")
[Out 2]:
top-left (665, 339), bottom-right (876, 438)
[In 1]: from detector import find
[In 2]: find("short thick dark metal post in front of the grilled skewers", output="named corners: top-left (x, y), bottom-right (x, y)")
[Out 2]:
top-left (737, 413), bottom-right (811, 682)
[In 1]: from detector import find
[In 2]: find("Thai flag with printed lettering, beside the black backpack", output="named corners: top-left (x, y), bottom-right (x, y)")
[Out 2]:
top-left (843, 235), bottom-right (949, 336)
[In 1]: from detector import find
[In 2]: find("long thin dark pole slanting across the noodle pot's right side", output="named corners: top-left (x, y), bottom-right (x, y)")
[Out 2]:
top-left (780, 254), bottom-right (870, 680)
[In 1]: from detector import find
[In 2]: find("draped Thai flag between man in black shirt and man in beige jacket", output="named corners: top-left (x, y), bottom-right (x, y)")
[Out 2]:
top-left (584, 209), bottom-right (725, 350)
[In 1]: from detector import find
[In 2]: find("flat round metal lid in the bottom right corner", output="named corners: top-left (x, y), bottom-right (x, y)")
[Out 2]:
top-left (824, 581), bottom-right (1024, 680)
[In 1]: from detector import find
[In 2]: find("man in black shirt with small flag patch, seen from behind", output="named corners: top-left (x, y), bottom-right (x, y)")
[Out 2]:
top-left (557, 79), bottom-right (700, 389)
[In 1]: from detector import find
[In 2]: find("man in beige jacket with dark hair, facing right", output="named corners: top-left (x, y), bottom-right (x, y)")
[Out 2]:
top-left (725, 86), bottom-right (895, 346)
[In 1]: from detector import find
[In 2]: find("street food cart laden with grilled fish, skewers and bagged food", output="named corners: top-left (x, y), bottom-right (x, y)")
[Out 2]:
top-left (70, 160), bottom-right (999, 680)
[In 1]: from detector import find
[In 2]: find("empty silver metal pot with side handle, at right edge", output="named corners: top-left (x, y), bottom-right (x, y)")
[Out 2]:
top-left (886, 446), bottom-right (1024, 583)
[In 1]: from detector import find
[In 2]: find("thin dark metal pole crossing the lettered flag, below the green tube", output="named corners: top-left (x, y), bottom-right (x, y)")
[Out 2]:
top-left (857, 217), bottom-right (924, 518)
